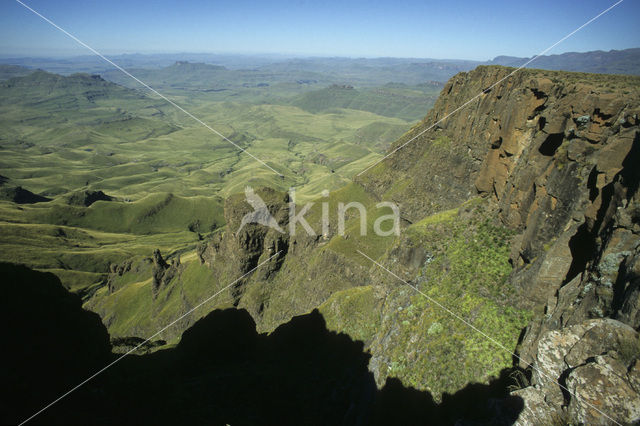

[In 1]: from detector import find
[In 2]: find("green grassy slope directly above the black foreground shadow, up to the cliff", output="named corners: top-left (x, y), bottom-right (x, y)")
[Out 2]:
top-left (86, 184), bottom-right (530, 399)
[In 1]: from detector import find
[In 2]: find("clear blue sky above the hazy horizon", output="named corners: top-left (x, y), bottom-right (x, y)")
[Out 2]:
top-left (0, 0), bottom-right (640, 60)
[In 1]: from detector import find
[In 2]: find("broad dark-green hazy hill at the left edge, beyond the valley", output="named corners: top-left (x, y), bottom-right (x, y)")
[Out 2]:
top-left (0, 70), bottom-right (176, 147)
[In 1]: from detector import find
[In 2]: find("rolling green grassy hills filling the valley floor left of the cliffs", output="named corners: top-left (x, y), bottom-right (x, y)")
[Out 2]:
top-left (0, 63), bottom-right (424, 290)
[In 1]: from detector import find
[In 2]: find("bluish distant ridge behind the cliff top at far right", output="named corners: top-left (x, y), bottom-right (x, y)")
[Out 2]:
top-left (488, 48), bottom-right (640, 75)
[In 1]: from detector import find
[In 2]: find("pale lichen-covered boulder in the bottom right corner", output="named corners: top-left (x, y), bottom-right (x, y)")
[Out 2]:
top-left (513, 319), bottom-right (640, 425)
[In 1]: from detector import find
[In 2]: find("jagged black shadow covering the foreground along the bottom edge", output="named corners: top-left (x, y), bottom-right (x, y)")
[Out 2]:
top-left (0, 264), bottom-right (523, 425)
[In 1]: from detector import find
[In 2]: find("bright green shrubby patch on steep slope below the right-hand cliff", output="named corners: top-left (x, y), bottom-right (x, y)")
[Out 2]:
top-left (372, 203), bottom-right (530, 398)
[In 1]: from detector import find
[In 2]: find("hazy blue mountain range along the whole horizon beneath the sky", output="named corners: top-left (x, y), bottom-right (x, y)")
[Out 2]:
top-left (0, 48), bottom-right (640, 87)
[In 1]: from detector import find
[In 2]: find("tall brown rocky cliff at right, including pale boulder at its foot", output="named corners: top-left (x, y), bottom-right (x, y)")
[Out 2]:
top-left (362, 67), bottom-right (640, 424)
